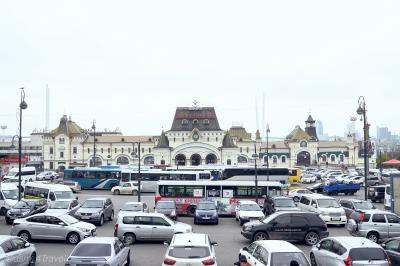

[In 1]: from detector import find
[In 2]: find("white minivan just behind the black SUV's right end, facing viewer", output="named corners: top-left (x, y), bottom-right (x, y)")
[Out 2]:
top-left (297, 194), bottom-right (347, 226)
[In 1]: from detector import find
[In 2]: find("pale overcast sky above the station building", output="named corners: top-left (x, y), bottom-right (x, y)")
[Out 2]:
top-left (0, 0), bottom-right (400, 137)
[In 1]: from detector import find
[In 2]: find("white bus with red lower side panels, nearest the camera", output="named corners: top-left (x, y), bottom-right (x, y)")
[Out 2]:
top-left (155, 181), bottom-right (282, 215)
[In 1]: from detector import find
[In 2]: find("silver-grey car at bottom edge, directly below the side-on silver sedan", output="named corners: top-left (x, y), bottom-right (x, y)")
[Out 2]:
top-left (65, 237), bottom-right (131, 266)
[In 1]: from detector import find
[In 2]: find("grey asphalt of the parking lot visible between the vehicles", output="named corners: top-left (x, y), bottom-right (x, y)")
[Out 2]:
top-left (0, 187), bottom-right (383, 266)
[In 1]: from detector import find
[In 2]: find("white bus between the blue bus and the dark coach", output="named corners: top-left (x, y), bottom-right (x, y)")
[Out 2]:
top-left (121, 169), bottom-right (211, 192)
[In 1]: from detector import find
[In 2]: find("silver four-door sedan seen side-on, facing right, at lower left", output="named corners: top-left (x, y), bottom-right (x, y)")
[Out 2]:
top-left (10, 213), bottom-right (96, 244)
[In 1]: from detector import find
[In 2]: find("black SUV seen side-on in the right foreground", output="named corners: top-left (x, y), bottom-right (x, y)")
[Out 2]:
top-left (241, 211), bottom-right (329, 246)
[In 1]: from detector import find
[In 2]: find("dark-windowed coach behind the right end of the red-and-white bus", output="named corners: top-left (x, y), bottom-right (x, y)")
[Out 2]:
top-left (221, 167), bottom-right (290, 184)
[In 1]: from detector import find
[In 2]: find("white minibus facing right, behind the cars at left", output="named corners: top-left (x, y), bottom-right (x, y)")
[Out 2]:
top-left (24, 182), bottom-right (76, 202)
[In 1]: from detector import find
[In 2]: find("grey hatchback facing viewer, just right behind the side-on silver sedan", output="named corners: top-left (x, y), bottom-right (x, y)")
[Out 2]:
top-left (74, 197), bottom-right (114, 226)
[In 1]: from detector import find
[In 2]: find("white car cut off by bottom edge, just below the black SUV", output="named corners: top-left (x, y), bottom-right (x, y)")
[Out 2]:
top-left (235, 240), bottom-right (310, 266)
